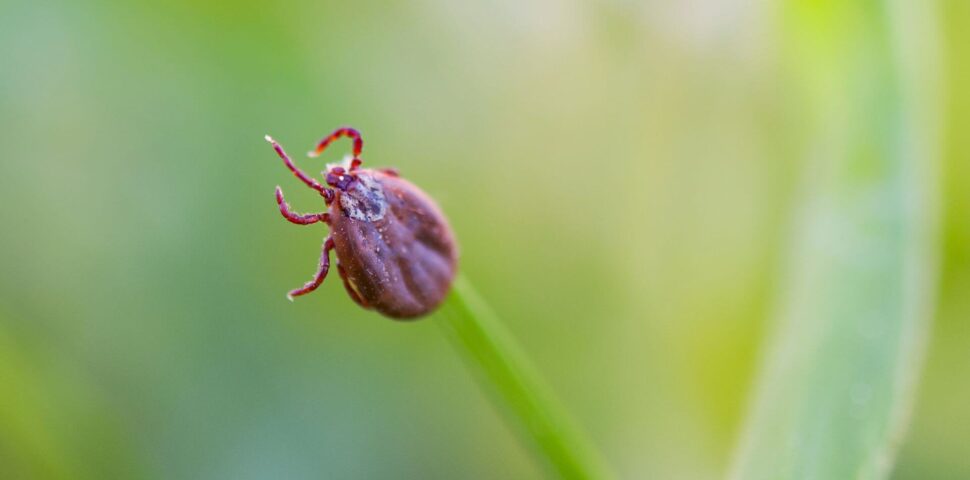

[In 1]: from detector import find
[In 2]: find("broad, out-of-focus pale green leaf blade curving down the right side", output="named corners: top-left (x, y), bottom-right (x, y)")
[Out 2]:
top-left (731, 1), bottom-right (937, 479)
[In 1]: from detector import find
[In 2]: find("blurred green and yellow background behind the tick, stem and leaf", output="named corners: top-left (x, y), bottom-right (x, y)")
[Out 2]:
top-left (0, 0), bottom-right (970, 479)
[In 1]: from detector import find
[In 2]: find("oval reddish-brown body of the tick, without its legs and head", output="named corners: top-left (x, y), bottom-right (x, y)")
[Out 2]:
top-left (331, 169), bottom-right (458, 318)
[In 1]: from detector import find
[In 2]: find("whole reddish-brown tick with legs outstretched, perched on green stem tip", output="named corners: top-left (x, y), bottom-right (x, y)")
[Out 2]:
top-left (266, 127), bottom-right (458, 319)
